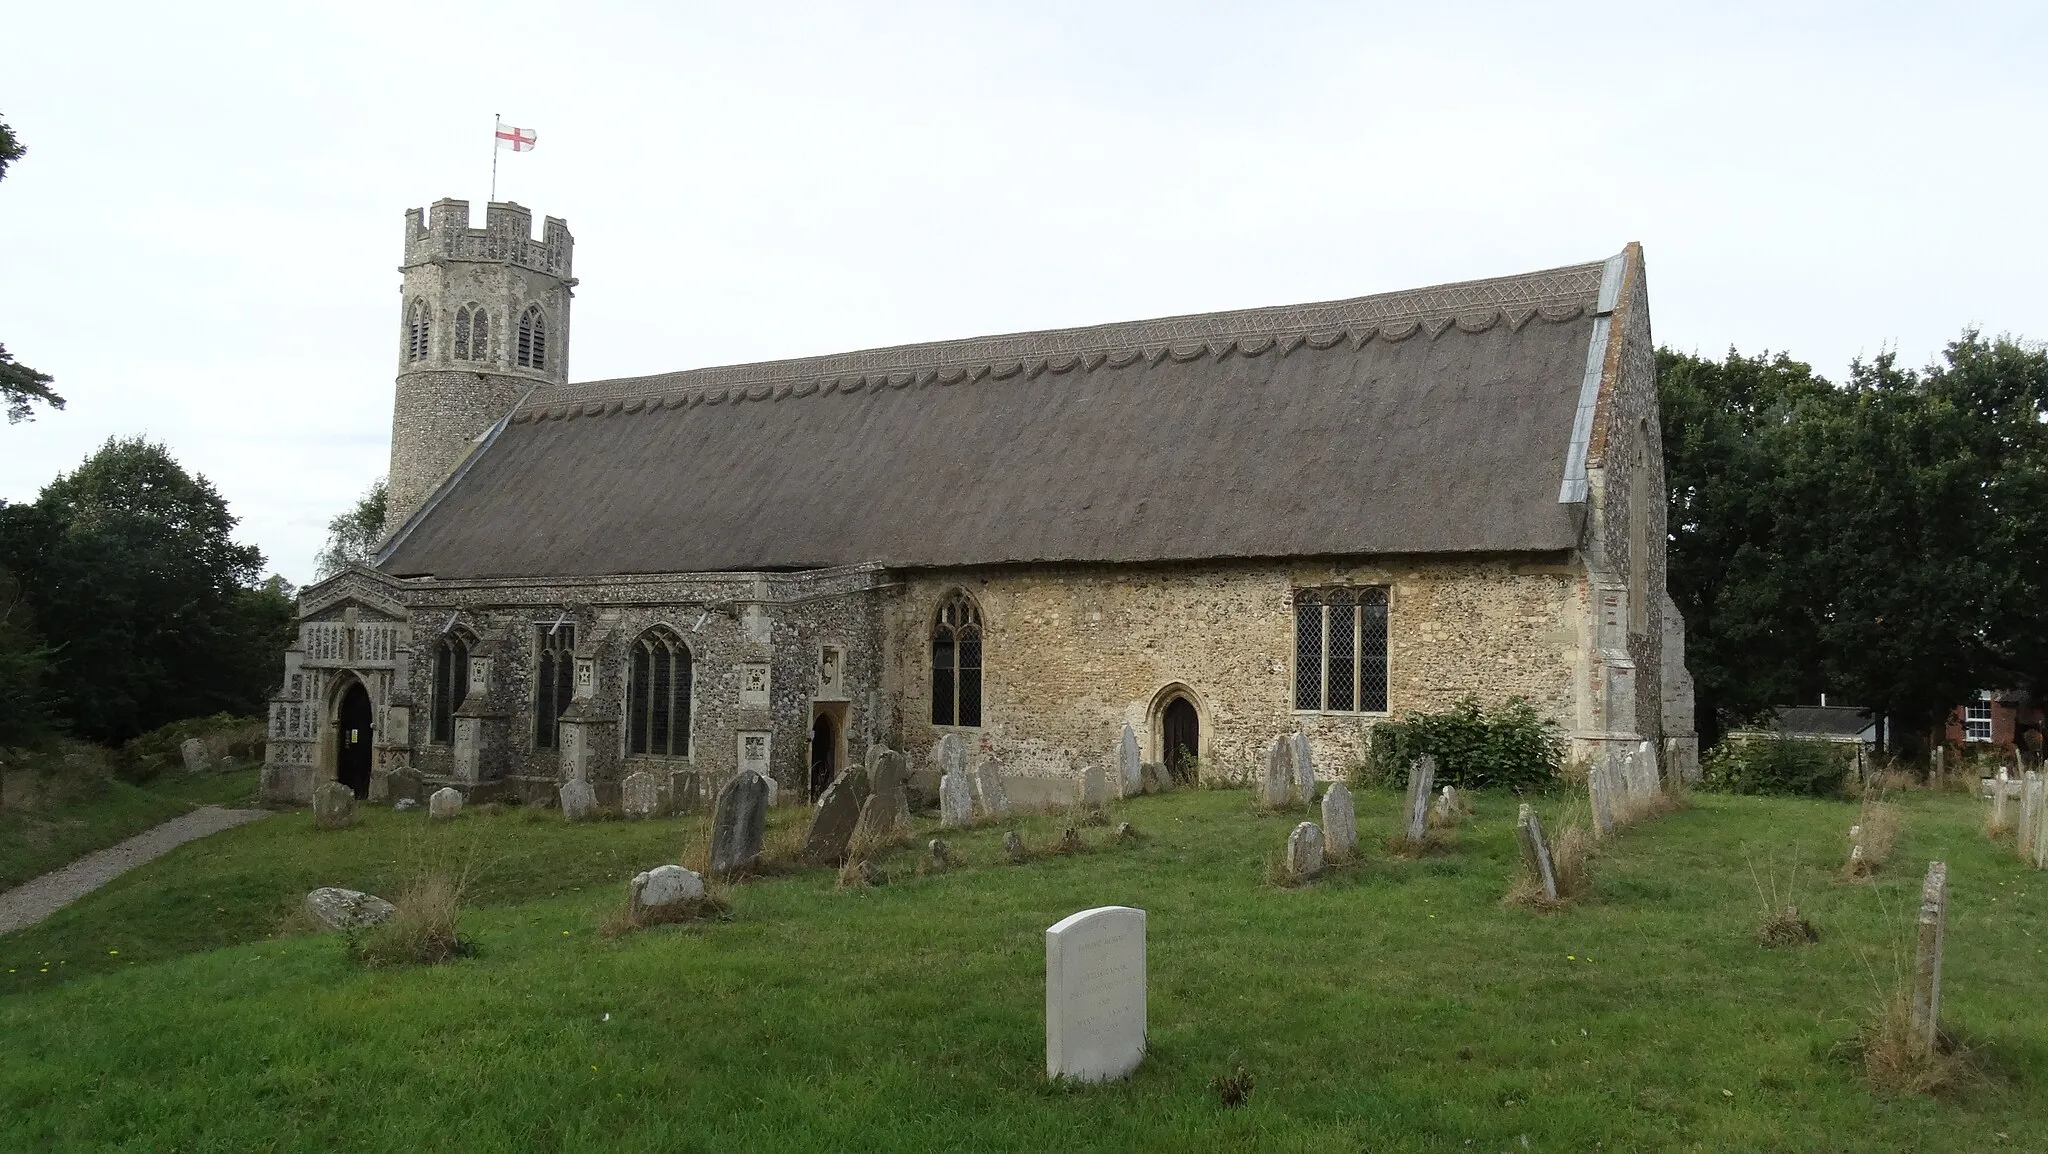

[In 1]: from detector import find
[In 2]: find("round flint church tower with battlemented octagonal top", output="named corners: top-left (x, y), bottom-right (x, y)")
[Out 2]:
top-left (385, 201), bottom-right (575, 535)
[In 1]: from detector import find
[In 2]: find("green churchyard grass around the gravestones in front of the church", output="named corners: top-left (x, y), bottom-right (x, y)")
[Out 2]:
top-left (0, 791), bottom-right (2048, 1150)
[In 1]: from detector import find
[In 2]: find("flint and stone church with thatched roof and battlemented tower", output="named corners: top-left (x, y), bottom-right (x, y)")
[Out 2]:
top-left (262, 201), bottom-right (1698, 803)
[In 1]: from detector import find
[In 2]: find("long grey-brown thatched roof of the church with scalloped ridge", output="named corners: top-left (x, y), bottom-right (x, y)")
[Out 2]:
top-left (379, 262), bottom-right (1602, 578)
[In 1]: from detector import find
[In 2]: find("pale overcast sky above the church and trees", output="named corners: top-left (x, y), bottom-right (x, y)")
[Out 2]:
top-left (0, 0), bottom-right (2048, 582)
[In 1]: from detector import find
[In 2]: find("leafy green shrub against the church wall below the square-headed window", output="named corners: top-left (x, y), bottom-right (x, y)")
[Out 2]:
top-left (1354, 697), bottom-right (1561, 789)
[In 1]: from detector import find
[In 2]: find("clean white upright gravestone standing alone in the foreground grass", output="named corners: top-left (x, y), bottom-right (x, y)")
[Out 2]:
top-left (1044, 906), bottom-right (1145, 1082)
